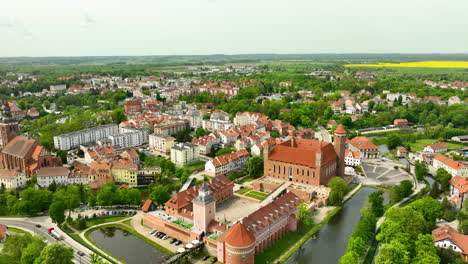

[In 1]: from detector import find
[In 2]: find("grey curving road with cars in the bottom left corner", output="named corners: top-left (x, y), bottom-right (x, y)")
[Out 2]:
top-left (0, 217), bottom-right (93, 264)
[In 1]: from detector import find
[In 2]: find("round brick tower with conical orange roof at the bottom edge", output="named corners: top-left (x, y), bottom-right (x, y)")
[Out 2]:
top-left (223, 222), bottom-right (255, 264)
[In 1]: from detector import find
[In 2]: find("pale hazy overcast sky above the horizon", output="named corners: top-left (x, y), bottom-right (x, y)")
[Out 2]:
top-left (0, 0), bottom-right (468, 57)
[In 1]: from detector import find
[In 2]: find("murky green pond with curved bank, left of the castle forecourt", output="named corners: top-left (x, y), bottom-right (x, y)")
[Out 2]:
top-left (90, 227), bottom-right (166, 264)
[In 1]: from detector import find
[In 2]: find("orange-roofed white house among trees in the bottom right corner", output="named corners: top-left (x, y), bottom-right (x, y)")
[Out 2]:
top-left (432, 224), bottom-right (468, 261)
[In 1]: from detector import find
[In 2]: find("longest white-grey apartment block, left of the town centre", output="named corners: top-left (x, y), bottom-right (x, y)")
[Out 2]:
top-left (54, 124), bottom-right (119, 150)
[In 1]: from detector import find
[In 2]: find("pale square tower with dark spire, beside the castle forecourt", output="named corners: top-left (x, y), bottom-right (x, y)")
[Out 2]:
top-left (193, 183), bottom-right (216, 234)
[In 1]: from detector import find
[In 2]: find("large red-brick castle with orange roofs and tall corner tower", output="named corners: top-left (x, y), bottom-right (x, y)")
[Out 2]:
top-left (263, 124), bottom-right (346, 186)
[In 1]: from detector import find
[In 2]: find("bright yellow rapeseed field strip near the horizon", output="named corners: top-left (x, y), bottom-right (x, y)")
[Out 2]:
top-left (344, 61), bottom-right (468, 68)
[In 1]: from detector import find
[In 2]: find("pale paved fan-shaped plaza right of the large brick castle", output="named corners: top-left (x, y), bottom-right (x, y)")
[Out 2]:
top-left (358, 159), bottom-right (414, 186)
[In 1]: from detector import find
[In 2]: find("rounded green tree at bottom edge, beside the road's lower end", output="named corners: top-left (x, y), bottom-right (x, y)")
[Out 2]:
top-left (34, 243), bottom-right (73, 264)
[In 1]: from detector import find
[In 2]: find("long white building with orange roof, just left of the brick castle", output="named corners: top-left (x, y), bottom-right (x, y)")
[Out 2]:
top-left (205, 149), bottom-right (250, 177)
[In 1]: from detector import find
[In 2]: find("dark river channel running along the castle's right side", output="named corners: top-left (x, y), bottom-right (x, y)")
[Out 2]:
top-left (286, 187), bottom-right (388, 264)
